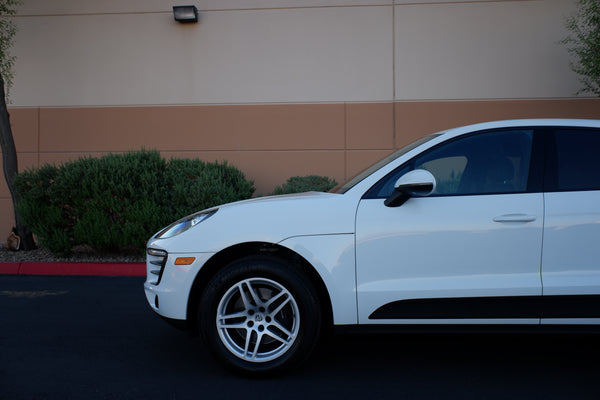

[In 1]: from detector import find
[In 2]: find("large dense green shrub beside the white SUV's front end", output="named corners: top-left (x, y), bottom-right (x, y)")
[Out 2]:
top-left (15, 150), bottom-right (254, 255)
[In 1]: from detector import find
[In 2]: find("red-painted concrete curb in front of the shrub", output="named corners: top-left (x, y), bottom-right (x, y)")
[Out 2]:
top-left (0, 262), bottom-right (146, 276)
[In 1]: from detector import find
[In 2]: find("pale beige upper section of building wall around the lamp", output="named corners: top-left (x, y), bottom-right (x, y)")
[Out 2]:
top-left (12, 0), bottom-right (578, 107)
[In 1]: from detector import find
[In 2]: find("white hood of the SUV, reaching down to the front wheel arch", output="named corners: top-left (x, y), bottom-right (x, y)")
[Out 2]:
top-left (148, 192), bottom-right (357, 253)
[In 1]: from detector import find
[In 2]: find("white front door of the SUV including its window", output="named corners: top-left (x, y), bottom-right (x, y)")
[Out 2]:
top-left (356, 129), bottom-right (543, 324)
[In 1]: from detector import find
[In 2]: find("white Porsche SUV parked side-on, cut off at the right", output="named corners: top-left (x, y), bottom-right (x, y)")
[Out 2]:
top-left (144, 119), bottom-right (600, 373)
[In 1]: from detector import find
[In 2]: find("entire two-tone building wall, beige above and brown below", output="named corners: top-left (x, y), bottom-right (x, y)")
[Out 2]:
top-left (0, 0), bottom-right (600, 241)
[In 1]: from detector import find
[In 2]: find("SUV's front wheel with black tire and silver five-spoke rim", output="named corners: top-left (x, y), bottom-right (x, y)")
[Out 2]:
top-left (198, 256), bottom-right (321, 374)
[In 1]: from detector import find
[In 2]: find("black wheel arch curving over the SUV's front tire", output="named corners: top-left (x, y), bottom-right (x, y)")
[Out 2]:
top-left (187, 242), bottom-right (333, 333)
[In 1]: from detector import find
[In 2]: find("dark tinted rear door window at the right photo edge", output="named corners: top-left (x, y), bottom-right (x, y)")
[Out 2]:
top-left (553, 129), bottom-right (600, 191)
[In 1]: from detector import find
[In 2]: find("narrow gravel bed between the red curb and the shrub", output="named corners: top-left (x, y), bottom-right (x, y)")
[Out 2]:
top-left (0, 244), bottom-right (146, 263)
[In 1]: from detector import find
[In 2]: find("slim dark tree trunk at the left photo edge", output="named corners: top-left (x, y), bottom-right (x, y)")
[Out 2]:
top-left (0, 77), bottom-right (36, 250)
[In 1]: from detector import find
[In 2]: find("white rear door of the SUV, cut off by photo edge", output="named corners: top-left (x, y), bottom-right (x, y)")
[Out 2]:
top-left (542, 128), bottom-right (600, 324)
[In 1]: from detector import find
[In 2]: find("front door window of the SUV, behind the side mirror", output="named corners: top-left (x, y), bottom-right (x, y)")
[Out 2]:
top-left (365, 130), bottom-right (533, 198)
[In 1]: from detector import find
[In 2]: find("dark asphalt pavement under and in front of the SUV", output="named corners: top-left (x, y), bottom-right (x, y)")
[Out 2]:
top-left (0, 275), bottom-right (600, 400)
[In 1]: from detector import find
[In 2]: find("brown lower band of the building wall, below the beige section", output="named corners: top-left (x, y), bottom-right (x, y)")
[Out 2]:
top-left (0, 98), bottom-right (600, 241)
